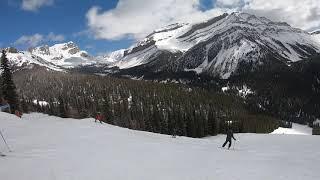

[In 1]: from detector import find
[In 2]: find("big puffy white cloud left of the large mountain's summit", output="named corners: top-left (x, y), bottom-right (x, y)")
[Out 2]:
top-left (86, 0), bottom-right (225, 40)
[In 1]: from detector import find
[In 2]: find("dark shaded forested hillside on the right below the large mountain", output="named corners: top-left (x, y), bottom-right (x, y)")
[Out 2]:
top-left (228, 56), bottom-right (320, 124)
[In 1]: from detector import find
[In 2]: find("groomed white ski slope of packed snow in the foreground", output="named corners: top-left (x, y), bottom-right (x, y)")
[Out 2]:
top-left (0, 113), bottom-right (320, 180)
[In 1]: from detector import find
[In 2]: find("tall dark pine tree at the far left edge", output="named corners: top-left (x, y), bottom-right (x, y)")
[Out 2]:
top-left (0, 50), bottom-right (18, 112)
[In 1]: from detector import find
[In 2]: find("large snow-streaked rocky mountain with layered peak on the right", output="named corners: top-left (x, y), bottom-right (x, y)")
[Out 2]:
top-left (104, 13), bottom-right (320, 78)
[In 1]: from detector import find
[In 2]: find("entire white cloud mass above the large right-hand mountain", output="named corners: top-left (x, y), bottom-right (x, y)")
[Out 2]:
top-left (86, 0), bottom-right (320, 40)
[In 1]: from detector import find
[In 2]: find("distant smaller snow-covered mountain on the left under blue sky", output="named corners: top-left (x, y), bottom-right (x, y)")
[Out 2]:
top-left (2, 42), bottom-right (96, 71)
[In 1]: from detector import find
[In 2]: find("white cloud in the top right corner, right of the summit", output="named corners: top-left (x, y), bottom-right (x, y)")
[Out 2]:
top-left (215, 0), bottom-right (320, 31)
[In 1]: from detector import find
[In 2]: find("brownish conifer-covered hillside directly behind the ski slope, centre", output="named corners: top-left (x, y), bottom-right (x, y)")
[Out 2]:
top-left (14, 68), bottom-right (278, 137)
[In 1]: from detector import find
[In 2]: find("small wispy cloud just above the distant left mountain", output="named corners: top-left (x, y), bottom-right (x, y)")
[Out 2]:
top-left (14, 32), bottom-right (65, 47)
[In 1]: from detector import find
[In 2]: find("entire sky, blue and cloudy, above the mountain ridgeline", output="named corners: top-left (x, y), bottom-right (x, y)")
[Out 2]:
top-left (0, 0), bottom-right (320, 55)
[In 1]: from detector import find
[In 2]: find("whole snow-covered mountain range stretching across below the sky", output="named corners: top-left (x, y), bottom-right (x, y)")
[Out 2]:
top-left (3, 13), bottom-right (320, 79)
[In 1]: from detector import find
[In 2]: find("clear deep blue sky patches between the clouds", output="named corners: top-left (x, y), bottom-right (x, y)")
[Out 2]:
top-left (0, 0), bottom-right (132, 54)
